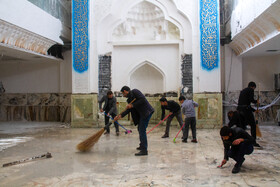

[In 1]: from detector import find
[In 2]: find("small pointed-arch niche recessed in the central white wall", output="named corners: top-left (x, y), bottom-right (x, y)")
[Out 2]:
top-left (130, 61), bottom-right (165, 94)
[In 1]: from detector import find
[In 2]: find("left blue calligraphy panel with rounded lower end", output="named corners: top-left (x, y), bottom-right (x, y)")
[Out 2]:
top-left (72, 0), bottom-right (89, 73)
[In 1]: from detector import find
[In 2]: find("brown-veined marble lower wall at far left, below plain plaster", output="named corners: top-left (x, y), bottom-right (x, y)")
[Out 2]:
top-left (0, 93), bottom-right (71, 123)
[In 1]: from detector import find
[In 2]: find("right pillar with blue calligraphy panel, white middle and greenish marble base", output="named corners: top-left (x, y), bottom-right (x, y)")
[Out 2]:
top-left (194, 0), bottom-right (222, 128)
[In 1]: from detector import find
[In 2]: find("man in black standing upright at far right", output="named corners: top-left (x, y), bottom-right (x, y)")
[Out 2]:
top-left (237, 82), bottom-right (260, 147)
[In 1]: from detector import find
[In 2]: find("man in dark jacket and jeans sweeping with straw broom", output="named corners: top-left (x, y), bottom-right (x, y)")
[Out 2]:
top-left (114, 86), bottom-right (154, 156)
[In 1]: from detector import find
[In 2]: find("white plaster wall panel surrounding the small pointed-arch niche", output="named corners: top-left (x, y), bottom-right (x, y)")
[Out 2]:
top-left (112, 44), bottom-right (180, 92)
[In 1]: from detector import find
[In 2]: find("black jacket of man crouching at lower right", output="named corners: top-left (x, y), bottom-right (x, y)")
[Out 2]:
top-left (222, 127), bottom-right (255, 160)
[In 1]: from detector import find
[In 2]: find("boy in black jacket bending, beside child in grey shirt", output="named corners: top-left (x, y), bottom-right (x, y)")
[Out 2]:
top-left (159, 97), bottom-right (183, 138)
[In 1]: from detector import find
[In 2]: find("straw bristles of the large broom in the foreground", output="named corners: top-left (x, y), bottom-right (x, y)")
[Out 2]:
top-left (77, 128), bottom-right (105, 152)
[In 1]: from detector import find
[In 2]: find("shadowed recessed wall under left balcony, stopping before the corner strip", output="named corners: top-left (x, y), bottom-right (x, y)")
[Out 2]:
top-left (0, 61), bottom-right (60, 93)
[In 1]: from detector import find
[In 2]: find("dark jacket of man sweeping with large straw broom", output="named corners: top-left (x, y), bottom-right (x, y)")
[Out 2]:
top-left (121, 89), bottom-right (154, 125)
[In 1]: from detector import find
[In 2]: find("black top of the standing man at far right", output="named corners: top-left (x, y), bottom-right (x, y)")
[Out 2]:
top-left (237, 87), bottom-right (257, 111)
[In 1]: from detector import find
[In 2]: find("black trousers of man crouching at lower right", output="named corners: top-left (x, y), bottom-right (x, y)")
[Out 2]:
top-left (228, 142), bottom-right (254, 167)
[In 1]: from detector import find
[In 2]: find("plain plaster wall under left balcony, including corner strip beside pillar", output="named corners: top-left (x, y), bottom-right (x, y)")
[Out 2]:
top-left (0, 51), bottom-right (72, 93)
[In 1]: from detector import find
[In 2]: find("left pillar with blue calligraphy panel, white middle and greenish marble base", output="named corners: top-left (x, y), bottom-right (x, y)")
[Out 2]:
top-left (71, 0), bottom-right (98, 127)
